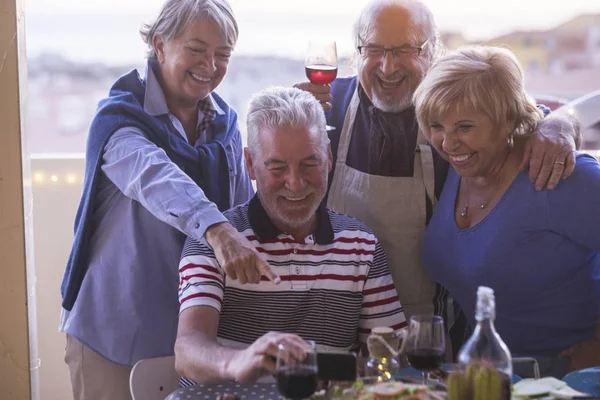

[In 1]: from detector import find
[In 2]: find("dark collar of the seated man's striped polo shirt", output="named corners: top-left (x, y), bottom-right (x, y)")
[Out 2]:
top-left (248, 194), bottom-right (333, 245)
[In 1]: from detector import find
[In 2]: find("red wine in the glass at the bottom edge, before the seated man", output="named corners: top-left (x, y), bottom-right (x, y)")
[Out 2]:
top-left (277, 365), bottom-right (317, 400)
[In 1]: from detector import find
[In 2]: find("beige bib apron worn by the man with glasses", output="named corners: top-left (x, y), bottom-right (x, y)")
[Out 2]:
top-left (327, 92), bottom-right (436, 319)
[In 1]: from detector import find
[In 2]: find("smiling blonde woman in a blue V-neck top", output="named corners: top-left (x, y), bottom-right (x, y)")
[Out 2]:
top-left (414, 47), bottom-right (600, 377)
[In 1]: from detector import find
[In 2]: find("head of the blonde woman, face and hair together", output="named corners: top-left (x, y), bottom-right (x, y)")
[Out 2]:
top-left (414, 46), bottom-right (541, 177)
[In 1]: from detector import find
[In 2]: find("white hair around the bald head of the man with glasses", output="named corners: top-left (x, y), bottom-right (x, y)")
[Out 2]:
top-left (352, 0), bottom-right (443, 61)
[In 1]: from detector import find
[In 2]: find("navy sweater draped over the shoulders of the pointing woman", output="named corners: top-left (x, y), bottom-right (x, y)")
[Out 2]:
top-left (61, 70), bottom-right (239, 310)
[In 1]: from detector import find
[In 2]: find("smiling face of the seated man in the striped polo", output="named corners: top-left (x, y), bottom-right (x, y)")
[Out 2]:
top-left (245, 126), bottom-right (332, 234)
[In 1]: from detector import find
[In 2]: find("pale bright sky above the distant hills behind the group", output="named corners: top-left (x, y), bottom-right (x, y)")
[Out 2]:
top-left (25, 0), bottom-right (600, 64)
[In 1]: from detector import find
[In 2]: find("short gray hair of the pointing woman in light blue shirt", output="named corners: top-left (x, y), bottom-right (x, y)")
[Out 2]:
top-left (140, 0), bottom-right (239, 58)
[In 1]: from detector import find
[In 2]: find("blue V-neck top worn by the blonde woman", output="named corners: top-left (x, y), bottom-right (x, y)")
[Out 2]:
top-left (423, 154), bottom-right (600, 356)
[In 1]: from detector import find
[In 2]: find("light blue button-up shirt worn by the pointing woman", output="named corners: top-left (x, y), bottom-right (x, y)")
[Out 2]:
top-left (60, 63), bottom-right (254, 366)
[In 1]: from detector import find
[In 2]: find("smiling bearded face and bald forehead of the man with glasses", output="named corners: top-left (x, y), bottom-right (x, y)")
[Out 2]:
top-left (358, 5), bottom-right (430, 112)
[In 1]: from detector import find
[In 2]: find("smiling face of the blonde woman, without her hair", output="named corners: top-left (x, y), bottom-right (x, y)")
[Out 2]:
top-left (426, 110), bottom-right (510, 177)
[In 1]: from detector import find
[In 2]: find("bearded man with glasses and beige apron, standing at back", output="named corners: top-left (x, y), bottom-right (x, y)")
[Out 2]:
top-left (296, 0), bottom-right (578, 346)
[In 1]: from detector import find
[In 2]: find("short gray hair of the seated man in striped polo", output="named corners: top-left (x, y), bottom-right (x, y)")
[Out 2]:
top-left (246, 87), bottom-right (329, 155)
